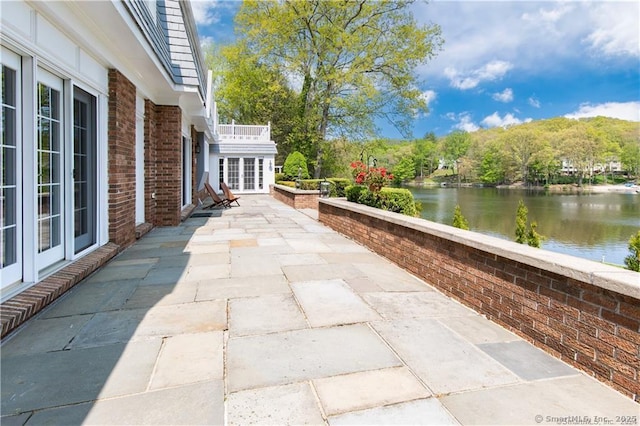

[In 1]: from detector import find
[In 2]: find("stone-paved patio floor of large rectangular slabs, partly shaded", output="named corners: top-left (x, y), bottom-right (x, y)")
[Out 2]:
top-left (0, 195), bottom-right (639, 425)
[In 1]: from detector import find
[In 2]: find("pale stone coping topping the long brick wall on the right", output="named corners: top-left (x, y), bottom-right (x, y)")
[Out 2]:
top-left (319, 198), bottom-right (640, 299)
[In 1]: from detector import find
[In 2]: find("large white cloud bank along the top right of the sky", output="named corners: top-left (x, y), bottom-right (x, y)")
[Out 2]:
top-left (413, 0), bottom-right (640, 78)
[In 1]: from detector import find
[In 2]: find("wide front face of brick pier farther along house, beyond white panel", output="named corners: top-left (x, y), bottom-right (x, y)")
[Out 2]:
top-left (154, 105), bottom-right (182, 226)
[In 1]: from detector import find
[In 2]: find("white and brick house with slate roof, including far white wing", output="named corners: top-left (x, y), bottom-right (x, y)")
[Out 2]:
top-left (0, 0), bottom-right (275, 301)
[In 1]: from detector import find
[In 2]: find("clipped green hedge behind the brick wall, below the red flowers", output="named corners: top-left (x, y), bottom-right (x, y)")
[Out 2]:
top-left (345, 185), bottom-right (418, 217)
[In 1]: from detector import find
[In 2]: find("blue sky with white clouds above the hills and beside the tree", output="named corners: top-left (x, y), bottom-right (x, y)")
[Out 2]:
top-left (192, 0), bottom-right (640, 138)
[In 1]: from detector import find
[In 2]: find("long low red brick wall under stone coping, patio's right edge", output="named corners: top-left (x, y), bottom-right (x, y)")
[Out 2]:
top-left (319, 202), bottom-right (640, 401)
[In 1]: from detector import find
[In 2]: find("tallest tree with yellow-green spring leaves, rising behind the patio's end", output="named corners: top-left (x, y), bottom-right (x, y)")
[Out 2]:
top-left (236, 0), bottom-right (442, 177)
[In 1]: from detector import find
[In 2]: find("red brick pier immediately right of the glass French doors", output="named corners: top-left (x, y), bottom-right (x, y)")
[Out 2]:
top-left (108, 69), bottom-right (136, 247)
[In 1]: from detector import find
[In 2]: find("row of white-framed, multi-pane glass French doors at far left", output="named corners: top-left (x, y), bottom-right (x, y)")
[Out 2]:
top-left (0, 47), bottom-right (98, 292)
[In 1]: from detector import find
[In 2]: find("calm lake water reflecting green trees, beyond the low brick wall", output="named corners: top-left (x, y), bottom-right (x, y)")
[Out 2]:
top-left (408, 187), bottom-right (640, 265)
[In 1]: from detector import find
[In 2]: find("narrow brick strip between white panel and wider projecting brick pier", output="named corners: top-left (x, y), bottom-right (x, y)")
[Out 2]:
top-left (144, 99), bottom-right (158, 224)
